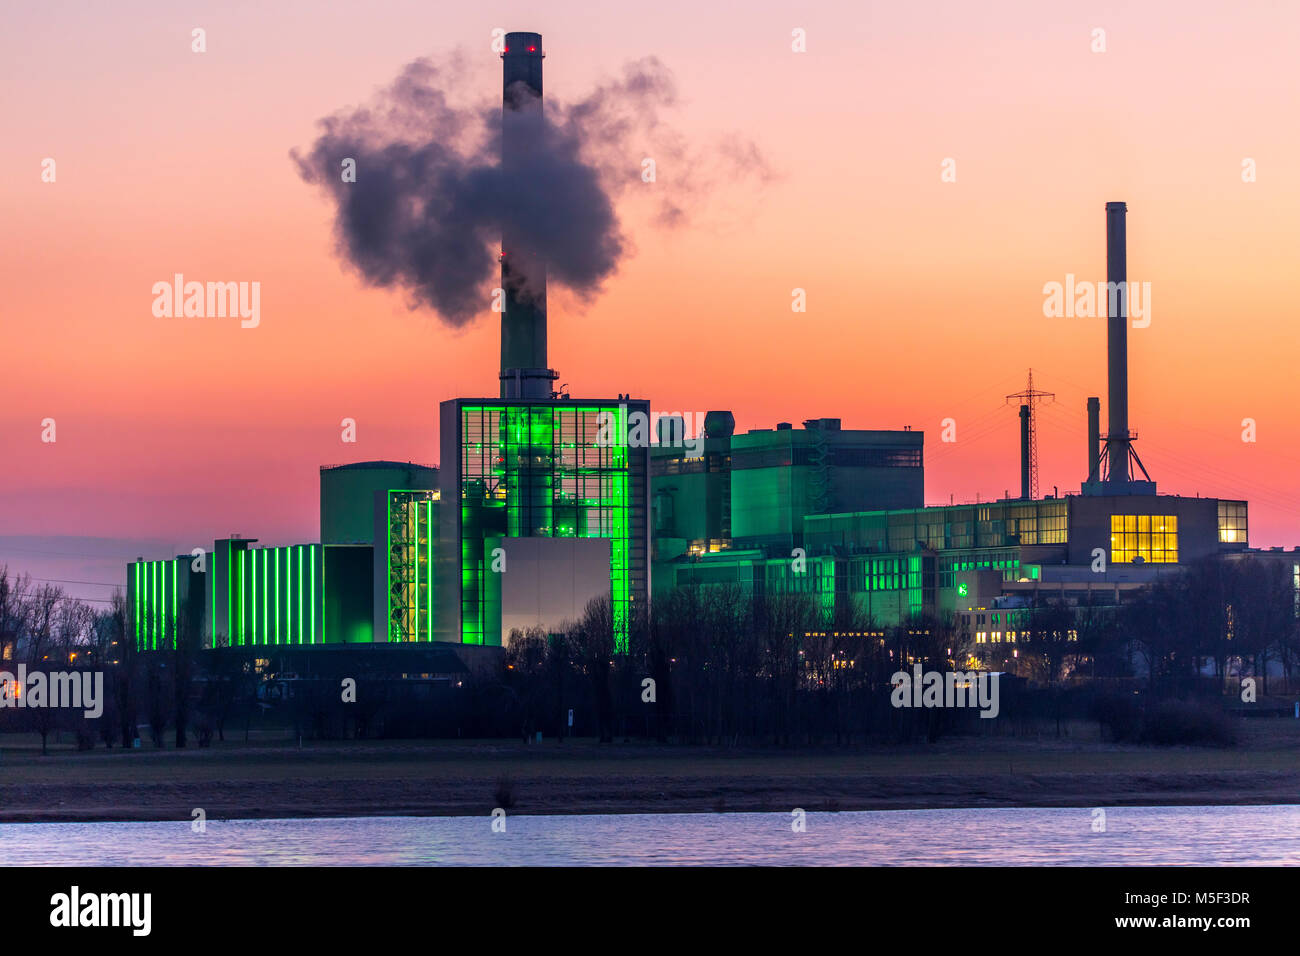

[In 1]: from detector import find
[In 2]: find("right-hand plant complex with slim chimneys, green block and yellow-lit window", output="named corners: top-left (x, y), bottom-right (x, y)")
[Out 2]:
top-left (651, 203), bottom-right (1253, 644)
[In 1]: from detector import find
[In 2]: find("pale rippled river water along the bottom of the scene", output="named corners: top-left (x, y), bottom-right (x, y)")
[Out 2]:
top-left (0, 805), bottom-right (1300, 866)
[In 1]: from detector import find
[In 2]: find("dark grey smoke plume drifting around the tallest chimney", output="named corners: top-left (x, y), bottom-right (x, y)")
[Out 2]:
top-left (291, 57), bottom-right (768, 326)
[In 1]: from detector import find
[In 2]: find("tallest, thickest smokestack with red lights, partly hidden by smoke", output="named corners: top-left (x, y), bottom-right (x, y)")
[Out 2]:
top-left (501, 33), bottom-right (556, 398)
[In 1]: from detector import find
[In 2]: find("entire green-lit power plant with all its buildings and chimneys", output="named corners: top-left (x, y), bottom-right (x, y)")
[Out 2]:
top-left (127, 33), bottom-right (1274, 665)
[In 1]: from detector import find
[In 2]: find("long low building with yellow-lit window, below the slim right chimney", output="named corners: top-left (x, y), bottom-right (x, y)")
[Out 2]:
top-left (657, 494), bottom-right (1247, 644)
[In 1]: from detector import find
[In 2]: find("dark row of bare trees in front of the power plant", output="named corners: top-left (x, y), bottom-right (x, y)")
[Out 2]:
top-left (0, 558), bottom-right (1300, 748)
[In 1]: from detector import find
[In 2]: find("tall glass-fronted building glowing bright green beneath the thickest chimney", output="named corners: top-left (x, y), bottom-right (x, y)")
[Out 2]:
top-left (438, 398), bottom-right (650, 645)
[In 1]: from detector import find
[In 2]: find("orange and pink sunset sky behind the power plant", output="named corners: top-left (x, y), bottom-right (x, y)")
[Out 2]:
top-left (0, 0), bottom-right (1300, 597)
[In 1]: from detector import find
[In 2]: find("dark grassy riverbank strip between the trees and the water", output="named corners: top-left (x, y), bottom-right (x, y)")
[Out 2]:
top-left (0, 719), bottom-right (1300, 822)
